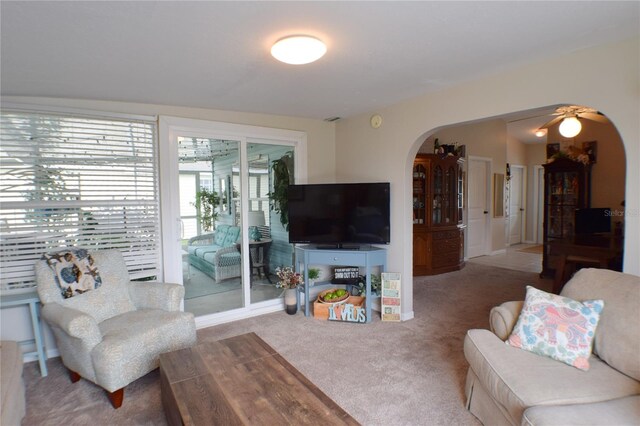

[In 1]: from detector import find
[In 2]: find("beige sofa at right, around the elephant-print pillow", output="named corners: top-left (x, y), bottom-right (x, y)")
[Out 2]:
top-left (464, 269), bottom-right (640, 426)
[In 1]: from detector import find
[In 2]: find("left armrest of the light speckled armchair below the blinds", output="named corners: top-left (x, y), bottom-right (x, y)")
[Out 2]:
top-left (42, 302), bottom-right (102, 348)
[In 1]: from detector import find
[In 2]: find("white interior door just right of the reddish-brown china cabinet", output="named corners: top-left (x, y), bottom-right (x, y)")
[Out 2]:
top-left (467, 157), bottom-right (491, 258)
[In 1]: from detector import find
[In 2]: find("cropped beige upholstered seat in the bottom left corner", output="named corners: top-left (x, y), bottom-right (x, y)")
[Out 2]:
top-left (0, 340), bottom-right (26, 426)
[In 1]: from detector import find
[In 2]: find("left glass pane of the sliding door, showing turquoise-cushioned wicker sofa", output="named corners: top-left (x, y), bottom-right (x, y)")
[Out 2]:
top-left (177, 136), bottom-right (244, 316)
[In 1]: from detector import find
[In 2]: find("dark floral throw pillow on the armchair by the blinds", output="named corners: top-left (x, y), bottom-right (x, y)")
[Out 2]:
top-left (42, 249), bottom-right (102, 299)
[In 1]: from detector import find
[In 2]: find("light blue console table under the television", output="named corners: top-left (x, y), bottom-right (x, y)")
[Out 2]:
top-left (295, 245), bottom-right (387, 322)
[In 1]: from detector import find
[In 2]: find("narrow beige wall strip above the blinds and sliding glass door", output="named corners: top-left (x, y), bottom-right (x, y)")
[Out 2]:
top-left (2, 96), bottom-right (336, 183)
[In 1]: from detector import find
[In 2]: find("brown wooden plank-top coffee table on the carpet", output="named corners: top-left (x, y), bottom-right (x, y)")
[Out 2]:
top-left (160, 333), bottom-right (358, 425)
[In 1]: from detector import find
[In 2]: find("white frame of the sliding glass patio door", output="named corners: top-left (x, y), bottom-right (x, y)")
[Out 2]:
top-left (158, 116), bottom-right (307, 327)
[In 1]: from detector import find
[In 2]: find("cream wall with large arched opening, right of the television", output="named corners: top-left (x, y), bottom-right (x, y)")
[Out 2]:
top-left (336, 38), bottom-right (640, 319)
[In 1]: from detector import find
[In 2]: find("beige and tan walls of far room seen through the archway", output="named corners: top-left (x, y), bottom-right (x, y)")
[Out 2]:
top-left (410, 106), bottom-right (626, 274)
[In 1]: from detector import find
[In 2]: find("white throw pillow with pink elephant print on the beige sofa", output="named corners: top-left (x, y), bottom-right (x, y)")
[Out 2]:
top-left (506, 286), bottom-right (604, 370)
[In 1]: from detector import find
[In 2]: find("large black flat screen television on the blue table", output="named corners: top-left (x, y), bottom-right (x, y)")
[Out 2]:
top-left (288, 182), bottom-right (391, 248)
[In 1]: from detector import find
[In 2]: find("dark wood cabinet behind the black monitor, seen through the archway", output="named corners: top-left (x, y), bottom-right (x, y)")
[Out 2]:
top-left (540, 158), bottom-right (591, 277)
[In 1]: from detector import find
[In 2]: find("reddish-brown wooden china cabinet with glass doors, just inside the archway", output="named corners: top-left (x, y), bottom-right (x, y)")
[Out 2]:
top-left (413, 154), bottom-right (464, 276)
